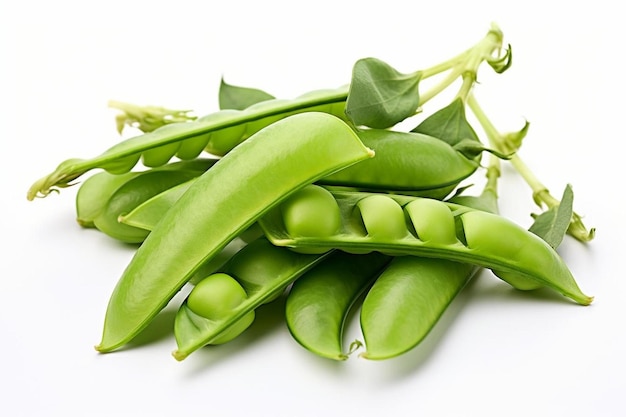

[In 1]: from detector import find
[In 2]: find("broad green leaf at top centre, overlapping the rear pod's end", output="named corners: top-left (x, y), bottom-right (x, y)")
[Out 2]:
top-left (346, 58), bottom-right (422, 129)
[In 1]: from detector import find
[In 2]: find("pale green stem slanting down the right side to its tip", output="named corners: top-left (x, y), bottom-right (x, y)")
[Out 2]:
top-left (467, 94), bottom-right (595, 242)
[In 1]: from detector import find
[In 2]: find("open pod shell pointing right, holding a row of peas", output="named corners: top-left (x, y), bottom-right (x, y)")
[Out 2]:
top-left (259, 191), bottom-right (593, 305)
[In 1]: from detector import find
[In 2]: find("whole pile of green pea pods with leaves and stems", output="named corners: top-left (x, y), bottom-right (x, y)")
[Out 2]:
top-left (28, 25), bottom-right (594, 360)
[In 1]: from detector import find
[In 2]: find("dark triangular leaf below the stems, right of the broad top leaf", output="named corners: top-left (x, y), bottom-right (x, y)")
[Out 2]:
top-left (412, 97), bottom-right (480, 146)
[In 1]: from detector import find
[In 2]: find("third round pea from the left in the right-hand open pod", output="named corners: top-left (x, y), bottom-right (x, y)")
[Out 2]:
top-left (404, 198), bottom-right (457, 245)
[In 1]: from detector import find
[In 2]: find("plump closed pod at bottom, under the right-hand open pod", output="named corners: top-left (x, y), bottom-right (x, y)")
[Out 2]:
top-left (359, 256), bottom-right (479, 360)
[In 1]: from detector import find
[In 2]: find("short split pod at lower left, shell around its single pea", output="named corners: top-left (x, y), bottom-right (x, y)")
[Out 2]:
top-left (173, 238), bottom-right (328, 360)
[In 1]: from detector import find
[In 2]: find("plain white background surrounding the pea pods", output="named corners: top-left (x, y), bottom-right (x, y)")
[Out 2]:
top-left (0, 0), bottom-right (626, 416)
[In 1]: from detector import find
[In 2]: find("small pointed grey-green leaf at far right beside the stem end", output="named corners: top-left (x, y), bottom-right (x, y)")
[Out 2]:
top-left (528, 184), bottom-right (574, 249)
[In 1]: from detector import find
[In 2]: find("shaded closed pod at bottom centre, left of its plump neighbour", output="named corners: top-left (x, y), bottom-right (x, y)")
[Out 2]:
top-left (285, 251), bottom-right (391, 360)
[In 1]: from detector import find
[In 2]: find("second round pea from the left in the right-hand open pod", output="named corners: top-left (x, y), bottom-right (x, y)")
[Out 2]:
top-left (357, 194), bottom-right (408, 239)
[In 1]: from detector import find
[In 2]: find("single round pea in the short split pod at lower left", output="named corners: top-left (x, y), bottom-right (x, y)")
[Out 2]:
top-left (187, 273), bottom-right (254, 344)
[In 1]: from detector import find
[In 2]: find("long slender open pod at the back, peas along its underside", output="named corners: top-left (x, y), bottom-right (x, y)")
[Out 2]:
top-left (27, 87), bottom-right (348, 200)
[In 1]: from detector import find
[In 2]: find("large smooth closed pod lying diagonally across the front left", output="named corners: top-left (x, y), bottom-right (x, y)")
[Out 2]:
top-left (96, 112), bottom-right (373, 352)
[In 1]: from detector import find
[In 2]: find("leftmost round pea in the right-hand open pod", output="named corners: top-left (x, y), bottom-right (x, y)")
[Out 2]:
top-left (280, 184), bottom-right (341, 237)
